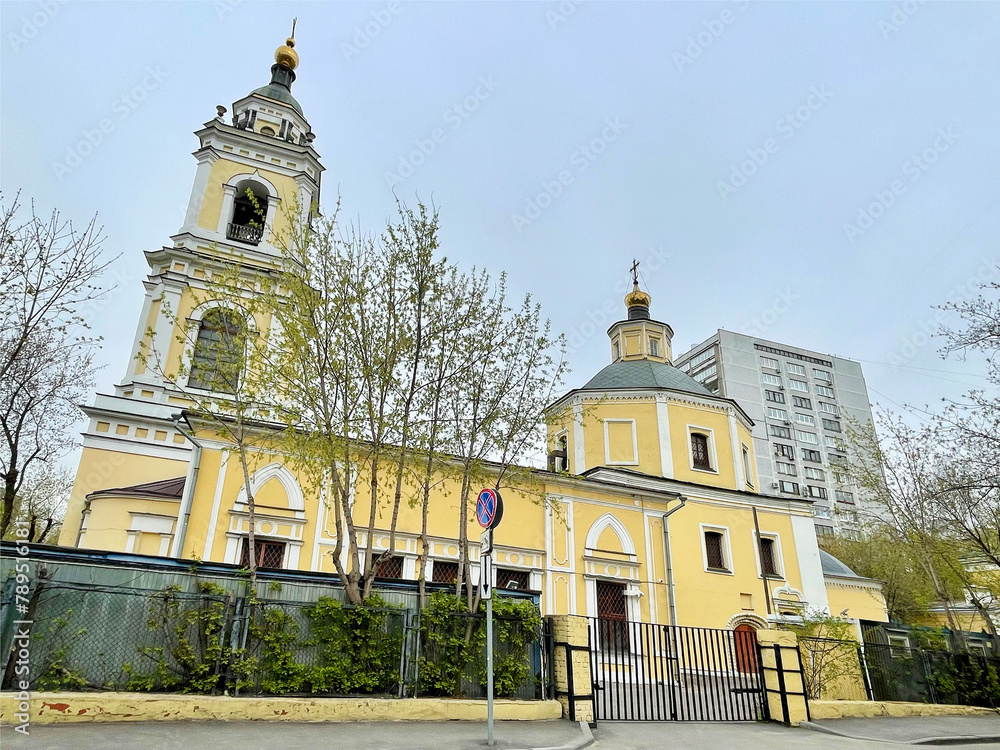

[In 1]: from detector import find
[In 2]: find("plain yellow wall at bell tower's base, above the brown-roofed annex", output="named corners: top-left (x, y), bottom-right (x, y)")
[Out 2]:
top-left (59, 447), bottom-right (188, 550)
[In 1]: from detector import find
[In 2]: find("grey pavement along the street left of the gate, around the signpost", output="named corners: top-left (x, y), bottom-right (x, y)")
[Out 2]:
top-left (0, 719), bottom-right (592, 750)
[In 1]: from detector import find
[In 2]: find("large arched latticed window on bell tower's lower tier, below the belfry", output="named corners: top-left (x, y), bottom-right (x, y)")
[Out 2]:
top-left (188, 309), bottom-right (246, 393)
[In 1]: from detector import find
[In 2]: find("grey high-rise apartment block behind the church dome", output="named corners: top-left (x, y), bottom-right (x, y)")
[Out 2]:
top-left (674, 329), bottom-right (872, 536)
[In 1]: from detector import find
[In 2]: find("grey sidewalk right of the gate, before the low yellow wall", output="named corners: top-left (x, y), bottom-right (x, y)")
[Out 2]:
top-left (802, 714), bottom-right (1000, 747)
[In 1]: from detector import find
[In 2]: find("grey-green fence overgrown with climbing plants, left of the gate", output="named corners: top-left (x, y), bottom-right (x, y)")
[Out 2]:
top-left (0, 581), bottom-right (551, 699)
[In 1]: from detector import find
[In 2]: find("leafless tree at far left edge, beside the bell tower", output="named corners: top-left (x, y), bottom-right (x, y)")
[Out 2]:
top-left (0, 192), bottom-right (114, 535)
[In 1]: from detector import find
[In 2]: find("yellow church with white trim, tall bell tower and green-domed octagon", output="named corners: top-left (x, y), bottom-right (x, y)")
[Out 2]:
top-left (60, 32), bottom-right (886, 629)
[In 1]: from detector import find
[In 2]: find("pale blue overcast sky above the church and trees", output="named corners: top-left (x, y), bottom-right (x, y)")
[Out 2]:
top-left (0, 2), bottom-right (1000, 458)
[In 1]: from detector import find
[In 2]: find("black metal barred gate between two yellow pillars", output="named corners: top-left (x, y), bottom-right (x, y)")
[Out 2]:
top-left (590, 617), bottom-right (768, 721)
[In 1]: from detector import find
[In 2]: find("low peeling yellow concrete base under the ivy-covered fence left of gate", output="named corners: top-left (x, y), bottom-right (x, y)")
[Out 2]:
top-left (0, 692), bottom-right (562, 725)
